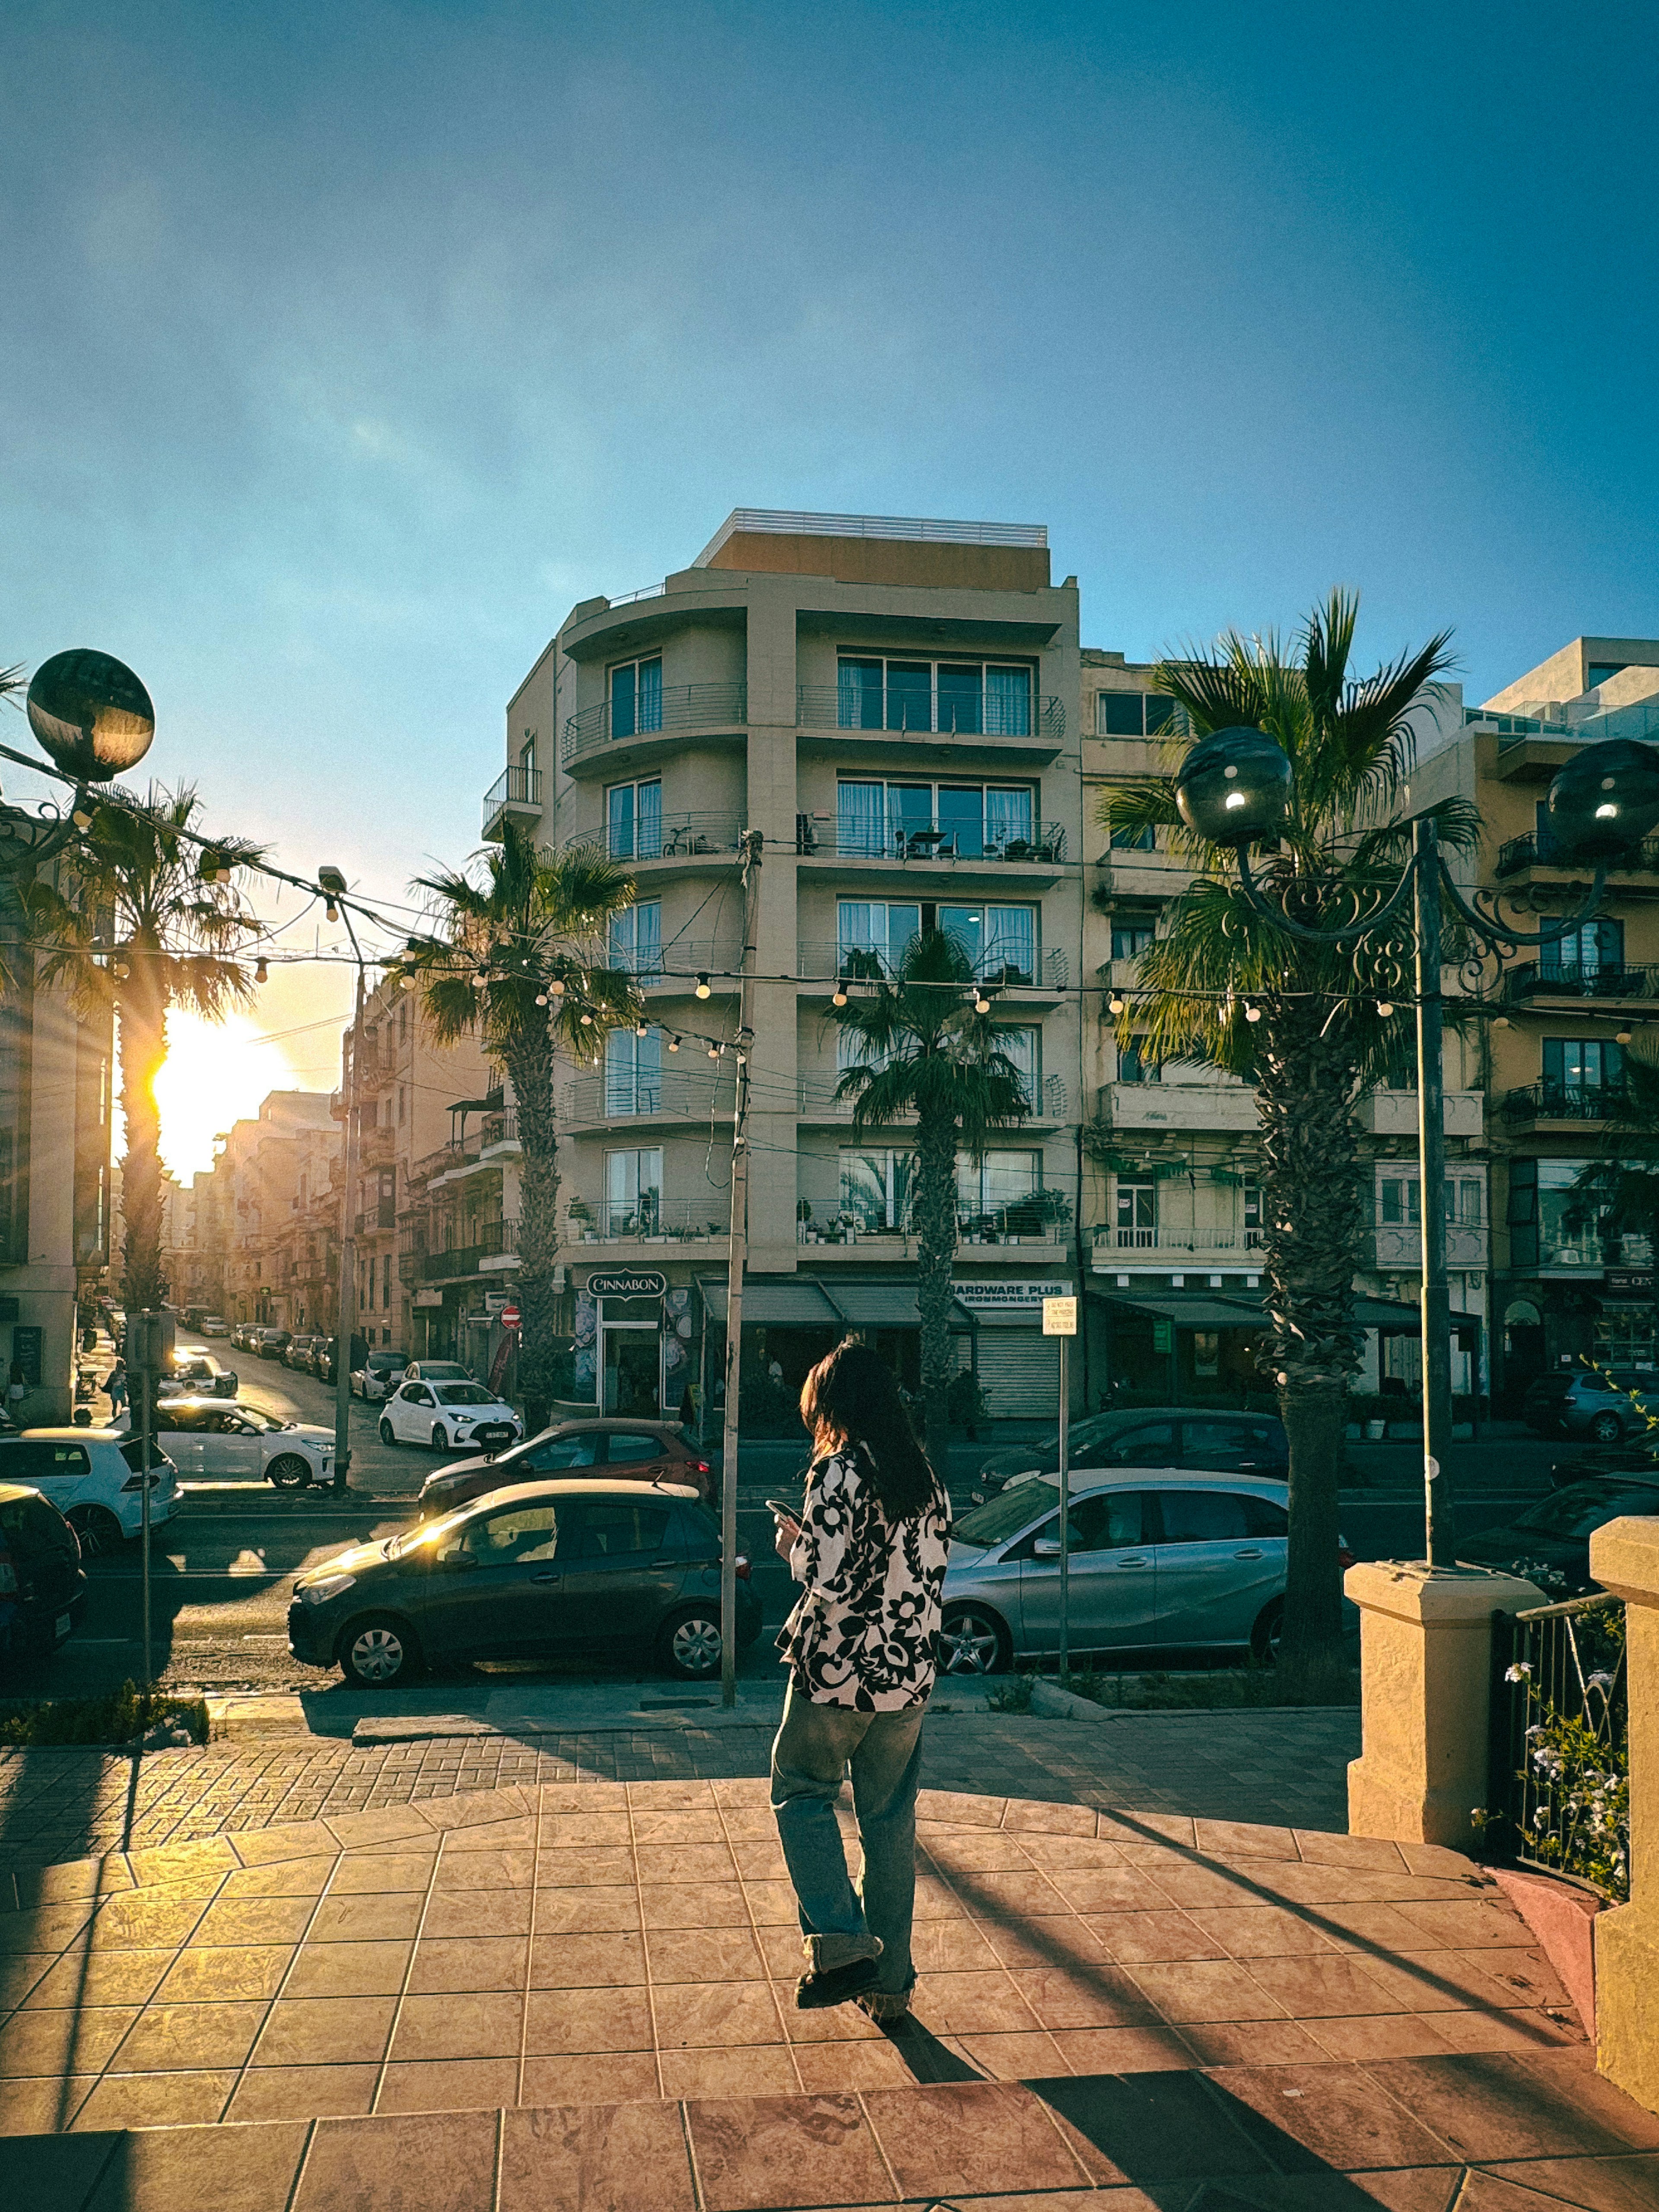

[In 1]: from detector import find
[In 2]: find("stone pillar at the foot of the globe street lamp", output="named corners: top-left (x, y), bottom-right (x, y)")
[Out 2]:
top-left (1343, 1559), bottom-right (1548, 1851)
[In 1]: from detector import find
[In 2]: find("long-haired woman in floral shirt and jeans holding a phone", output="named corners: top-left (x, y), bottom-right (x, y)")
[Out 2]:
top-left (772, 1338), bottom-right (951, 2019)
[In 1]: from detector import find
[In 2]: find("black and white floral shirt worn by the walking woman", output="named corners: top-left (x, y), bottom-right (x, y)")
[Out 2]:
top-left (779, 1447), bottom-right (951, 1712)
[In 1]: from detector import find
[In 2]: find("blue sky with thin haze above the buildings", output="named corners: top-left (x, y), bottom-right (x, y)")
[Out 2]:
top-left (0, 0), bottom-right (1659, 1159)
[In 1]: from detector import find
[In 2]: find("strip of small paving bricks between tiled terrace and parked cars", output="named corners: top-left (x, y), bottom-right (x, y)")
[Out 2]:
top-left (0, 1710), bottom-right (1360, 1867)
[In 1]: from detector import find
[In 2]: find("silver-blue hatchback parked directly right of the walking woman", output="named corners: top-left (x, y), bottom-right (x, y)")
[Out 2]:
top-left (940, 1469), bottom-right (1354, 1675)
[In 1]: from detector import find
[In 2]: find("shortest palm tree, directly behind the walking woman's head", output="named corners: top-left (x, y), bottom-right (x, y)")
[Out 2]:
top-left (832, 931), bottom-right (1031, 1469)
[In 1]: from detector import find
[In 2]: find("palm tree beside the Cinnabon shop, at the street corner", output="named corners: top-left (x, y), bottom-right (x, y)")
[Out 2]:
top-left (407, 821), bottom-right (642, 1436)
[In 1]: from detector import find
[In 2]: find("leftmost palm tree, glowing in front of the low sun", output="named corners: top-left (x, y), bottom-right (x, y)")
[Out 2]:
top-left (18, 783), bottom-right (261, 1312)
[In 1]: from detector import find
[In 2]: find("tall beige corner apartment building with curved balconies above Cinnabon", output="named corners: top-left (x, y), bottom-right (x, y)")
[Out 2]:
top-left (484, 511), bottom-right (1095, 1411)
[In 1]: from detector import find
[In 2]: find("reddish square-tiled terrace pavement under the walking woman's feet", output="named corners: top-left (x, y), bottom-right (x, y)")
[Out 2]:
top-left (0, 1778), bottom-right (1659, 2212)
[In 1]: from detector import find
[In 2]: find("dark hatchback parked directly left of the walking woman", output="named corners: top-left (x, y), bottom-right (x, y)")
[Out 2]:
top-left (288, 1482), bottom-right (761, 1688)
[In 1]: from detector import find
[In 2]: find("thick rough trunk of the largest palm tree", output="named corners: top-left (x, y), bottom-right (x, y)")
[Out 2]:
top-left (1256, 1000), bottom-right (1365, 1659)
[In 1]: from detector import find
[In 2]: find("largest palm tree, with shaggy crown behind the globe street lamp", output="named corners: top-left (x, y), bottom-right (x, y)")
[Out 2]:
top-left (1102, 590), bottom-right (1480, 1657)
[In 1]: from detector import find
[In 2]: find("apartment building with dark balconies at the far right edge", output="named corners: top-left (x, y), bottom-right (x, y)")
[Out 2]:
top-left (1414, 637), bottom-right (1659, 1407)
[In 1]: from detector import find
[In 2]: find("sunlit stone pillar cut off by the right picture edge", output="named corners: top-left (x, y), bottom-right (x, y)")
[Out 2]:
top-left (1590, 1520), bottom-right (1659, 2113)
